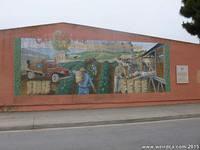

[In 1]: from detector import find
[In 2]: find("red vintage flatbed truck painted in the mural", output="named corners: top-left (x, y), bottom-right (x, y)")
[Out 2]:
top-left (26, 60), bottom-right (69, 82)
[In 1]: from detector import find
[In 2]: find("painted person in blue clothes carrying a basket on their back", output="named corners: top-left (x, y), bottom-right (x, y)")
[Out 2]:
top-left (77, 68), bottom-right (96, 95)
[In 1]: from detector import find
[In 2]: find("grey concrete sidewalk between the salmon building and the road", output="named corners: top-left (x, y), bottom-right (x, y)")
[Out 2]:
top-left (0, 103), bottom-right (200, 131)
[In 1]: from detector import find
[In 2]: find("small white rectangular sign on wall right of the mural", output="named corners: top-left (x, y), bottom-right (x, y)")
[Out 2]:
top-left (176, 65), bottom-right (189, 84)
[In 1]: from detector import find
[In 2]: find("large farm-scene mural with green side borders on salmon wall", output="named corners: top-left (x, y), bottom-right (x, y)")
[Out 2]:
top-left (15, 32), bottom-right (170, 95)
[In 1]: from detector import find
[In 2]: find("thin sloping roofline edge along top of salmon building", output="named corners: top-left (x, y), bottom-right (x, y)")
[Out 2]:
top-left (0, 22), bottom-right (199, 45)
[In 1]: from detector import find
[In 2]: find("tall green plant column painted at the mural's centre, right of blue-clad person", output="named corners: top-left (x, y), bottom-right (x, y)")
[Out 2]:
top-left (97, 62), bottom-right (110, 94)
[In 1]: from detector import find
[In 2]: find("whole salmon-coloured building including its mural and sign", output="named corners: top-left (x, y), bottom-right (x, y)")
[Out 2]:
top-left (0, 23), bottom-right (200, 111)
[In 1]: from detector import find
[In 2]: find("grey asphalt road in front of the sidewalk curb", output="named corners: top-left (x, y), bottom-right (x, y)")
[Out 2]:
top-left (0, 118), bottom-right (200, 150)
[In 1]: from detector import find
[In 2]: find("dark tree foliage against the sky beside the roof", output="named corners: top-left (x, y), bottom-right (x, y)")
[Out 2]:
top-left (180, 0), bottom-right (200, 39)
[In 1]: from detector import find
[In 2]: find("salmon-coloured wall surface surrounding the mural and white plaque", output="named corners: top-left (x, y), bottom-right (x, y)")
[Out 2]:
top-left (0, 23), bottom-right (200, 110)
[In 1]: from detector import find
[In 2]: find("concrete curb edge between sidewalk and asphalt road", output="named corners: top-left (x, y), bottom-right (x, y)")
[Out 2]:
top-left (0, 114), bottom-right (200, 131)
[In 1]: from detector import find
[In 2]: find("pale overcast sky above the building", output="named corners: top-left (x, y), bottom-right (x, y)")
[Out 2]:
top-left (0, 0), bottom-right (199, 43)
